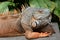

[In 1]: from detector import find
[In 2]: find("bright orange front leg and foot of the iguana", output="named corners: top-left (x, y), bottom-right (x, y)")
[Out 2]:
top-left (25, 32), bottom-right (51, 39)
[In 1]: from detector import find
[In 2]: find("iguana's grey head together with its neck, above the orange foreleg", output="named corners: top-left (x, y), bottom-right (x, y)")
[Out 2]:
top-left (21, 7), bottom-right (50, 27)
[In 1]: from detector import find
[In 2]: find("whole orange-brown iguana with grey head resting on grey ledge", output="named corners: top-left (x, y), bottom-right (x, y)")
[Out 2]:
top-left (0, 7), bottom-right (54, 38)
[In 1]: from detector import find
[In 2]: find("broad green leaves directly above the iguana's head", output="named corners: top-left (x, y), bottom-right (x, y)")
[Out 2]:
top-left (29, 0), bottom-right (55, 11)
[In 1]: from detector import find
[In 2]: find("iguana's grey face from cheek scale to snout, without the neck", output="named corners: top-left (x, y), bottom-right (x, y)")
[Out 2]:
top-left (32, 9), bottom-right (51, 27)
